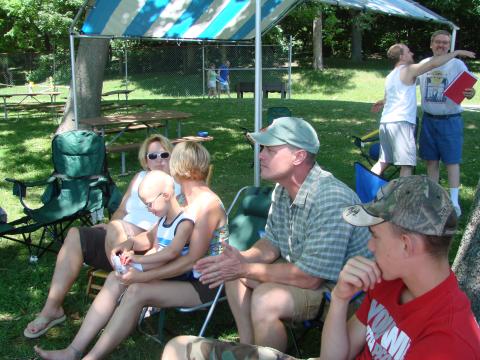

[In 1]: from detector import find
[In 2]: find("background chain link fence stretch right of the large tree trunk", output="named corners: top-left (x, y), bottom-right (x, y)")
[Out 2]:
top-left (105, 44), bottom-right (290, 97)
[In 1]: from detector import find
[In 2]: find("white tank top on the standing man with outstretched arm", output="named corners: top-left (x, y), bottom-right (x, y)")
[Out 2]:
top-left (380, 65), bottom-right (417, 124)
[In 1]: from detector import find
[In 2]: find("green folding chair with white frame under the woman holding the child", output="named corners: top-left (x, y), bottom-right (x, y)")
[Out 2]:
top-left (138, 186), bottom-right (273, 344)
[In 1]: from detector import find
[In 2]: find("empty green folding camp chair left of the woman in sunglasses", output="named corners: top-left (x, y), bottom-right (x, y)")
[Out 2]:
top-left (0, 130), bottom-right (122, 262)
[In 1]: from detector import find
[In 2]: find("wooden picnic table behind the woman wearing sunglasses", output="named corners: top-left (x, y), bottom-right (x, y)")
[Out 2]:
top-left (80, 110), bottom-right (192, 144)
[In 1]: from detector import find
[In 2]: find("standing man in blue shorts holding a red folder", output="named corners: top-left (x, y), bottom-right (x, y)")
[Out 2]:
top-left (418, 30), bottom-right (475, 216)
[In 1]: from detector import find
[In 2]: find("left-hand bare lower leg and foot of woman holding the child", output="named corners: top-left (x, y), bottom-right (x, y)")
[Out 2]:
top-left (35, 272), bottom-right (126, 360)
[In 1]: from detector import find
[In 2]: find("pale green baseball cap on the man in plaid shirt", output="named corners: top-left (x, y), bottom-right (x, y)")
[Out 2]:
top-left (247, 117), bottom-right (320, 154)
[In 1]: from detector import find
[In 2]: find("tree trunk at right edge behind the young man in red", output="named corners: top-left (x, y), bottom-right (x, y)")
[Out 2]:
top-left (452, 180), bottom-right (480, 321)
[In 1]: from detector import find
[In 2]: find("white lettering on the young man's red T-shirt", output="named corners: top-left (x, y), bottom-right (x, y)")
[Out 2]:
top-left (366, 300), bottom-right (411, 360)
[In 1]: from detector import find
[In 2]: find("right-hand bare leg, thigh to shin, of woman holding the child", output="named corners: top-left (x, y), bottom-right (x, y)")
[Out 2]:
top-left (84, 281), bottom-right (201, 360)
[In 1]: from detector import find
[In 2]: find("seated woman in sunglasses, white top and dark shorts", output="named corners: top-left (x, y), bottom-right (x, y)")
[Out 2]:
top-left (24, 135), bottom-right (176, 338)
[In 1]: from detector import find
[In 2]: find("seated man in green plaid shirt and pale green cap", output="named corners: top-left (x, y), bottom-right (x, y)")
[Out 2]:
top-left (195, 117), bottom-right (368, 350)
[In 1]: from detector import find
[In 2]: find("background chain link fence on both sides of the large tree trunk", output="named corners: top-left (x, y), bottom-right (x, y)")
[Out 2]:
top-left (0, 41), bottom-right (291, 97)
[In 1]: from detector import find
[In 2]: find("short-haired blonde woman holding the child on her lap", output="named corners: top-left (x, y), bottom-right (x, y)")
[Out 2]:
top-left (35, 142), bottom-right (228, 360)
